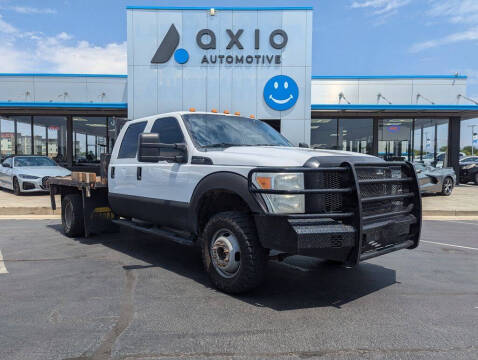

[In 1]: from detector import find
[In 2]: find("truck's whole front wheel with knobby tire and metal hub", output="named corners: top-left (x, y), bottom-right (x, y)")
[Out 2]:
top-left (202, 211), bottom-right (268, 294)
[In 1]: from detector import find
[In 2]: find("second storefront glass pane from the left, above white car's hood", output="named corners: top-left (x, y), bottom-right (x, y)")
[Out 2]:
top-left (33, 116), bottom-right (67, 164)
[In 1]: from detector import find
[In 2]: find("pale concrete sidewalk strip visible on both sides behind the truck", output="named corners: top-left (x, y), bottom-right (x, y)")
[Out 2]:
top-left (0, 185), bottom-right (478, 216)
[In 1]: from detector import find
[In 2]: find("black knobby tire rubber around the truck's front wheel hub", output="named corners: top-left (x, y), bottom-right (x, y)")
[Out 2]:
top-left (201, 211), bottom-right (269, 294)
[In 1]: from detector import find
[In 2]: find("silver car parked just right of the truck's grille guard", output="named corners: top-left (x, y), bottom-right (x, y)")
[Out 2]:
top-left (414, 162), bottom-right (456, 196)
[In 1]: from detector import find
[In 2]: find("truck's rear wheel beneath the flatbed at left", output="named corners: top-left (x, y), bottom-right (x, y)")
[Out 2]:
top-left (61, 194), bottom-right (85, 237)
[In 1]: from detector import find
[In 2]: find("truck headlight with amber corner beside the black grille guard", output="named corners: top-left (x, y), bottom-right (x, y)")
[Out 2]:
top-left (252, 173), bottom-right (305, 214)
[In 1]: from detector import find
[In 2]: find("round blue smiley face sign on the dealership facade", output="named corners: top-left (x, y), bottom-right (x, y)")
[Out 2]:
top-left (264, 75), bottom-right (299, 111)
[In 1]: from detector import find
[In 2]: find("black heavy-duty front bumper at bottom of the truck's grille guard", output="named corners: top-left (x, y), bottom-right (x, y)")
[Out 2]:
top-left (255, 215), bottom-right (417, 264)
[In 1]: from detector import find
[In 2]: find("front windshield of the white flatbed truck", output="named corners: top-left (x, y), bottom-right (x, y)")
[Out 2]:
top-left (183, 114), bottom-right (292, 148)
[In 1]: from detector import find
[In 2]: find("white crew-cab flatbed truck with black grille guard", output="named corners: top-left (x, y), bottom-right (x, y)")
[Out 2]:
top-left (50, 112), bottom-right (421, 293)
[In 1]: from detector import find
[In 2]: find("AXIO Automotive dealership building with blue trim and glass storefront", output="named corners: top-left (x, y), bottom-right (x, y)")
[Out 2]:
top-left (0, 7), bottom-right (478, 180)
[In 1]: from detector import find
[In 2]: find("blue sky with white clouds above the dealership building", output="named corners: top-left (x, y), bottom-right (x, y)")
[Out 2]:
top-left (0, 0), bottom-right (478, 146)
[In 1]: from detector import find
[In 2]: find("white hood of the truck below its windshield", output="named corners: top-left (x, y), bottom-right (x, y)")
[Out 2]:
top-left (204, 146), bottom-right (378, 166)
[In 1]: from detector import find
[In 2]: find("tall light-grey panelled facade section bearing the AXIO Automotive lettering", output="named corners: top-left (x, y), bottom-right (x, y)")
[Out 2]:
top-left (127, 7), bottom-right (312, 143)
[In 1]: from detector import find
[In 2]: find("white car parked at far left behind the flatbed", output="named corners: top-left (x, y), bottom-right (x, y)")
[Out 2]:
top-left (0, 155), bottom-right (71, 195)
